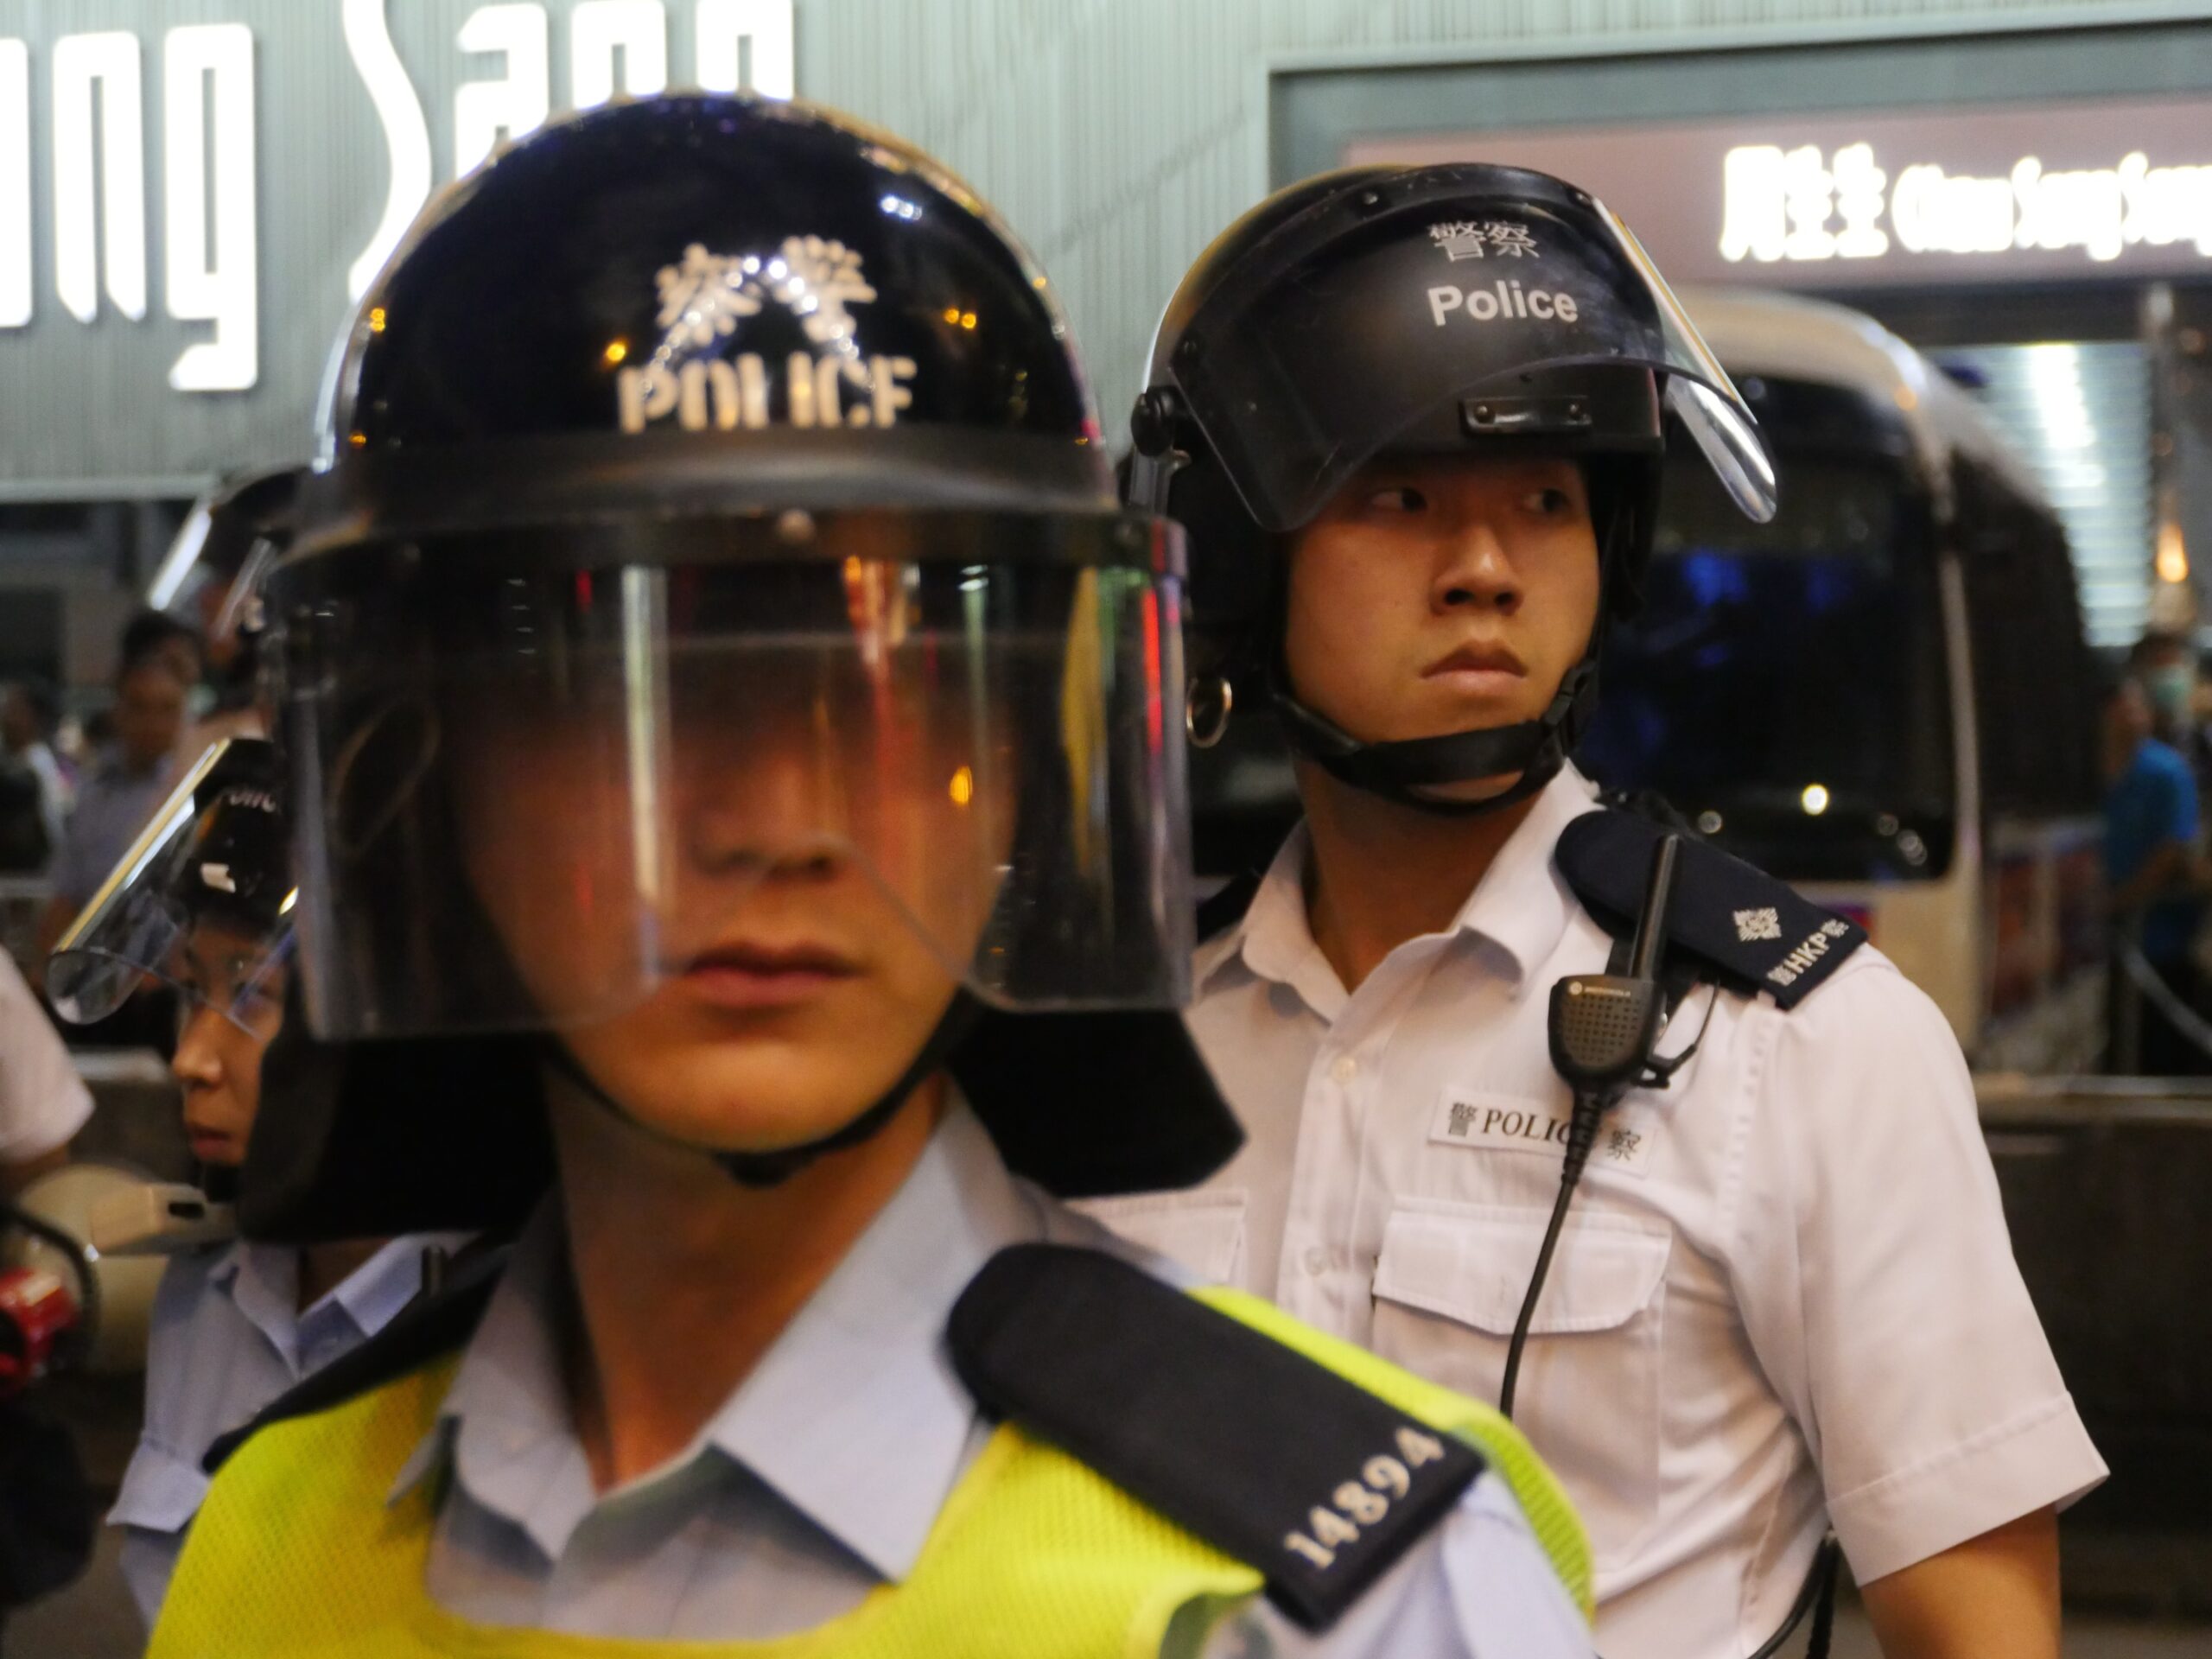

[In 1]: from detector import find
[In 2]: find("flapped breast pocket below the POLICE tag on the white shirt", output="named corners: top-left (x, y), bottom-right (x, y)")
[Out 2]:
top-left (1374, 1204), bottom-right (1672, 1571)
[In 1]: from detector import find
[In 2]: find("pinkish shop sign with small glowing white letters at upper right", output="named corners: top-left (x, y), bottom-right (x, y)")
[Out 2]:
top-left (1344, 98), bottom-right (2212, 288)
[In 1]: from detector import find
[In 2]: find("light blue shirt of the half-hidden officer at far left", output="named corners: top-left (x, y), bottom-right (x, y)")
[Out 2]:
top-left (108, 1232), bottom-right (469, 1628)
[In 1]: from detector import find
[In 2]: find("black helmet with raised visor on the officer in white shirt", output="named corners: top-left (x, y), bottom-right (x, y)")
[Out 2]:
top-left (1128, 163), bottom-right (1774, 812)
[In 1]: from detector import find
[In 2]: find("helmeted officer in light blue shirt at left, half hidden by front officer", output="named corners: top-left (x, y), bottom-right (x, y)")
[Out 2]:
top-left (47, 739), bottom-right (467, 1628)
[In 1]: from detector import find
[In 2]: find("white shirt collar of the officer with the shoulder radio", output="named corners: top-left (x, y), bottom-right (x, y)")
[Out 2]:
top-left (1194, 766), bottom-right (1597, 1022)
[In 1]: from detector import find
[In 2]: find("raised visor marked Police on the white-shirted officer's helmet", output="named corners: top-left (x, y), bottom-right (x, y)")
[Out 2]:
top-left (1173, 201), bottom-right (1774, 533)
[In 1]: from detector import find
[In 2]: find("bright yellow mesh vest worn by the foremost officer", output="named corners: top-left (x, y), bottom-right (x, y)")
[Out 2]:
top-left (149, 1292), bottom-right (1591, 1659)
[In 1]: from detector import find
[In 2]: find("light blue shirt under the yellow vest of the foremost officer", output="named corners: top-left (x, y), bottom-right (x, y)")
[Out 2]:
top-left (391, 1106), bottom-right (1591, 1659)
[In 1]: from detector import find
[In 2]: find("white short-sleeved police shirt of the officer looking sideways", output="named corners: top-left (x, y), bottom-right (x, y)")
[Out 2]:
top-left (1084, 770), bottom-right (2106, 1659)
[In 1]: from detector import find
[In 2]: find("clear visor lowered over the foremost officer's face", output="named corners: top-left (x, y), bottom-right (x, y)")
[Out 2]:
top-left (279, 513), bottom-right (1190, 1038)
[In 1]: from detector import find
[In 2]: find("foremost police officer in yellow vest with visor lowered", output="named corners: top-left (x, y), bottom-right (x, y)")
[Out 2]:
top-left (153, 98), bottom-right (1588, 1659)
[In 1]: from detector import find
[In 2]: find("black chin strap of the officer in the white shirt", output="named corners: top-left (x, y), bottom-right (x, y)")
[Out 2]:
top-left (1269, 646), bottom-right (1597, 818)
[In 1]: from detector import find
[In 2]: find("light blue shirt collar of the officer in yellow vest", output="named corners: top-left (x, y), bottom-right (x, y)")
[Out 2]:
top-left (391, 1102), bottom-right (1042, 1580)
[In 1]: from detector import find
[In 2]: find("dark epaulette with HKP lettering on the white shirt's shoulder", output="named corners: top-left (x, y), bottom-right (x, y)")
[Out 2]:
top-left (1553, 810), bottom-right (1867, 1008)
